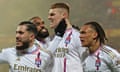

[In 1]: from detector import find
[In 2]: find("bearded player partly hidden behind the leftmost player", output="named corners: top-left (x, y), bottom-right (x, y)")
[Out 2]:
top-left (30, 16), bottom-right (51, 48)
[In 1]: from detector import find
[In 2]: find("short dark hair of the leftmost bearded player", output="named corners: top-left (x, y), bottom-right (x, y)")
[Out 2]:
top-left (19, 21), bottom-right (38, 36)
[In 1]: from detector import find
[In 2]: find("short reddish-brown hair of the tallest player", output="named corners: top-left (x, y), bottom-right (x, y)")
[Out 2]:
top-left (50, 3), bottom-right (70, 13)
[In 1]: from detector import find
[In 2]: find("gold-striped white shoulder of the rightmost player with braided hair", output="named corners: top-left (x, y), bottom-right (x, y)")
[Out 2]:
top-left (101, 45), bottom-right (117, 59)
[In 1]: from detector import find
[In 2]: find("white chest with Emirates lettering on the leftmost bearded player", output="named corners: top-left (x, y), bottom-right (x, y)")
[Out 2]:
top-left (9, 54), bottom-right (44, 72)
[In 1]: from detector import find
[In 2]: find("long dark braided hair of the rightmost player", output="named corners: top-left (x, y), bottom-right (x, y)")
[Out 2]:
top-left (84, 21), bottom-right (108, 44)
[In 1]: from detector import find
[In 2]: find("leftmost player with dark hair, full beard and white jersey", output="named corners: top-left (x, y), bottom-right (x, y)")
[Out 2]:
top-left (0, 21), bottom-right (66, 72)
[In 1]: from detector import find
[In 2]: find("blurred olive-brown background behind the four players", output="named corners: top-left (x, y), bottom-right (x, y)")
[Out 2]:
top-left (0, 0), bottom-right (120, 72)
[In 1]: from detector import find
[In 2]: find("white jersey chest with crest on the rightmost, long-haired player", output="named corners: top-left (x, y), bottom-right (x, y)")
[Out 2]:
top-left (83, 55), bottom-right (110, 72)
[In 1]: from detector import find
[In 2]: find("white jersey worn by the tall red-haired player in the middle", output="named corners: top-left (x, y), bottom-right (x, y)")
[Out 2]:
top-left (49, 28), bottom-right (83, 72)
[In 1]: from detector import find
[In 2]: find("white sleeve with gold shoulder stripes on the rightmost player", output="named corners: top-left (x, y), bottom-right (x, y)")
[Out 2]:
top-left (103, 46), bottom-right (120, 72)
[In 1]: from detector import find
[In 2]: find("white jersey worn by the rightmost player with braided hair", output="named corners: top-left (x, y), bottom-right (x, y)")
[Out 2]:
top-left (83, 45), bottom-right (120, 72)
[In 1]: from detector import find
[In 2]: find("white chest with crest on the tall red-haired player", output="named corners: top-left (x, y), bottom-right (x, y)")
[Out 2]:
top-left (54, 31), bottom-right (80, 58)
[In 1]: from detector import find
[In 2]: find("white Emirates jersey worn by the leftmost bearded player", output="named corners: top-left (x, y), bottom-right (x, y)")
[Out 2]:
top-left (0, 37), bottom-right (61, 72)
